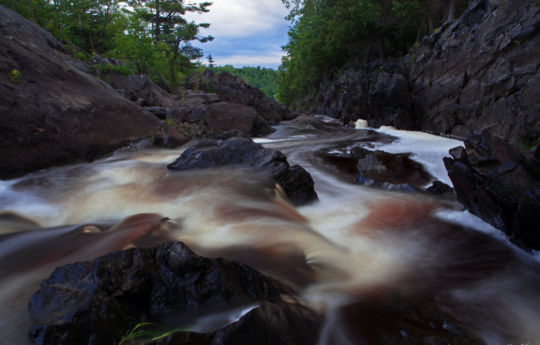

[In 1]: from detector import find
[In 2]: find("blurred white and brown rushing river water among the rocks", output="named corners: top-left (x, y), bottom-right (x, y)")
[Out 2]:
top-left (0, 117), bottom-right (540, 345)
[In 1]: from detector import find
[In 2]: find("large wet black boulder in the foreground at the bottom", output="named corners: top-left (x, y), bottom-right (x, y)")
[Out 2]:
top-left (28, 243), bottom-right (320, 345)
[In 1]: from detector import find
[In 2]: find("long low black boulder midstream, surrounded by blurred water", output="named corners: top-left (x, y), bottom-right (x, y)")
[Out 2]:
top-left (167, 138), bottom-right (317, 205)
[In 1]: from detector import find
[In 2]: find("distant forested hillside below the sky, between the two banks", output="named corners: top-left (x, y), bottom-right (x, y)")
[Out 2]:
top-left (212, 65), bottom-right (279, 99)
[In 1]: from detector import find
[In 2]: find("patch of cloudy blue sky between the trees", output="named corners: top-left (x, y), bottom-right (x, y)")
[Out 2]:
top-left (189, 0), bottom-right (289, 68)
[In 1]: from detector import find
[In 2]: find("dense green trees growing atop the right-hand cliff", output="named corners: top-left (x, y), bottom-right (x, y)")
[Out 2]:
top-left (278, 0), bottom-right (468, 105)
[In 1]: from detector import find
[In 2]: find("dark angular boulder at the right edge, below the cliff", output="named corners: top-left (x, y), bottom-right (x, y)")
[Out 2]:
top-left (444, 131), bottom-right (540, 249)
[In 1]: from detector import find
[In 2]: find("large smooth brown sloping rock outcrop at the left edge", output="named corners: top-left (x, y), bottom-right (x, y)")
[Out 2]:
top-left (0, 6), bottom-right (158, 178)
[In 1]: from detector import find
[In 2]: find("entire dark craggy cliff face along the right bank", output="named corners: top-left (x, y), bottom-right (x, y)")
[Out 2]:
top-left (304, 0), bottom-right (540, 145)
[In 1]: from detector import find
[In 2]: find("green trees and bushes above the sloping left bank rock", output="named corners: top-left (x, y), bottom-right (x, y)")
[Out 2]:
top-left (0, 0), bottom-right (213, 90)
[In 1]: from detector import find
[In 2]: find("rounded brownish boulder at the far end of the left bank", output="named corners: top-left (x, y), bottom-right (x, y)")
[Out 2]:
top-left (204, 102), bottom-right (257, 134)
